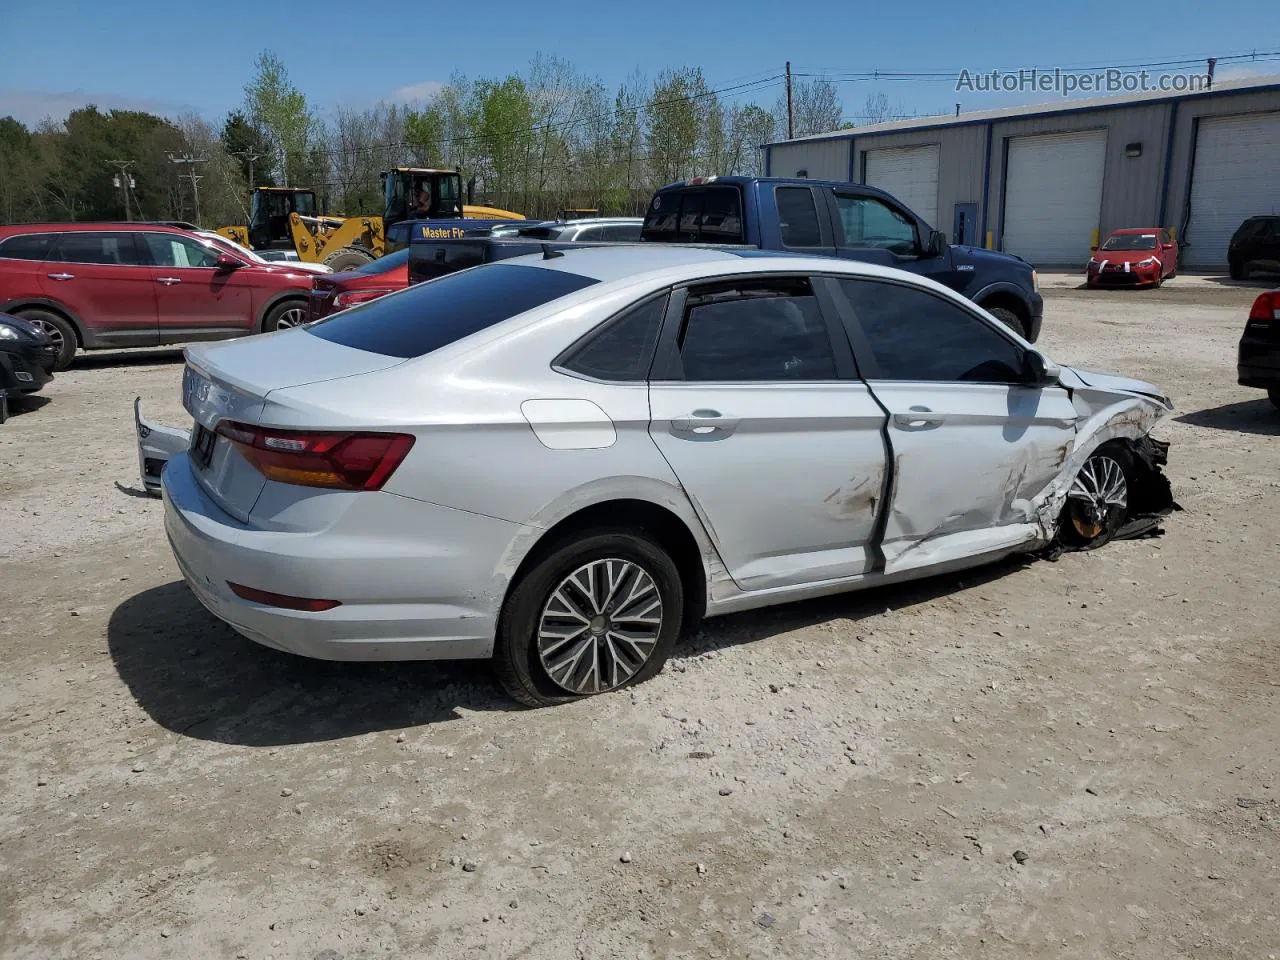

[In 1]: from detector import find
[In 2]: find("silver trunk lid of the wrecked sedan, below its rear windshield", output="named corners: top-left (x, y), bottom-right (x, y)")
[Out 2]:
top-left (182, 329), bottom-right (404, 522)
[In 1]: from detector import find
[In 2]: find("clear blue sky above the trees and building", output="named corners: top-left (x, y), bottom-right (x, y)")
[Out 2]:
top-left (0, 0), bottom-right (1280, 123)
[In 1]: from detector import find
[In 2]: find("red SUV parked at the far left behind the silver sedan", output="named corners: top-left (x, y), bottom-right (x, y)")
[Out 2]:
top-left (0, 223), bottom-right (311, 370)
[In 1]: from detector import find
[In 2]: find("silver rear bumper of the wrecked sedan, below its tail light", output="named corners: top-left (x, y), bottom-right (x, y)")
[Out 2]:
top-left (163, 453), bottom-right (520, 660)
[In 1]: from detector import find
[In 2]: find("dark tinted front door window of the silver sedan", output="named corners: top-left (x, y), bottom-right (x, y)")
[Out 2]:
top-left (840, 280), bottom-right (1023, 384)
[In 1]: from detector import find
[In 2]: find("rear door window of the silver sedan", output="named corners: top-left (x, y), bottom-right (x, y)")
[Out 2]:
top-left (680, 278), bottom-right (837, 383)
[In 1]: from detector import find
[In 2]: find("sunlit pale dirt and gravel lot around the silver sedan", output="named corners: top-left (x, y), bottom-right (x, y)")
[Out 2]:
top-left (0, 278), bottom-right (1280, 960)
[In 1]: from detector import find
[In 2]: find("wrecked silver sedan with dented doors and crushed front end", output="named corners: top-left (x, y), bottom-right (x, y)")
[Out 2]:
top-left (138, 244), bottom-right (1174, 704)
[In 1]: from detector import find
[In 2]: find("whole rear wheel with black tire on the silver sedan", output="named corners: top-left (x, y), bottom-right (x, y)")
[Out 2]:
top-left (494, 530), bottom-right (685, 707)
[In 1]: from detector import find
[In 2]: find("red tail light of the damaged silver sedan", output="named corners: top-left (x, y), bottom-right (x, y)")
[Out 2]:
top-left (216, 420), bottom-right (413, 490)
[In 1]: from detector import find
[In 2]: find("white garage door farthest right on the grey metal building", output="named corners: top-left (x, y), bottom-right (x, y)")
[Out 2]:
top-left (1180, 113), bottom-right (1280, 268)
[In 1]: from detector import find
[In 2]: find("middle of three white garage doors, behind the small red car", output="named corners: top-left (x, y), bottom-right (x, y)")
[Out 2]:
top-left (1004, 131), bottom-right (1107, 266)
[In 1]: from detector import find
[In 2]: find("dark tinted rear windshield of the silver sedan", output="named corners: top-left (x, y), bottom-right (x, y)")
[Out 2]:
top-left (307, 264), bottom-right (598, 358)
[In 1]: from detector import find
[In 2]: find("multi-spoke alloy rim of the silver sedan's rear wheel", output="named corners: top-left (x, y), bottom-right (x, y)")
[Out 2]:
top-left (538, 558), bottom-right (663, 696)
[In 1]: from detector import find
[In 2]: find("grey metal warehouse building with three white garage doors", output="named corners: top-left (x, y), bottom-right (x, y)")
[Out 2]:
top-left (763, 77), bottom-right (1280, 270)
